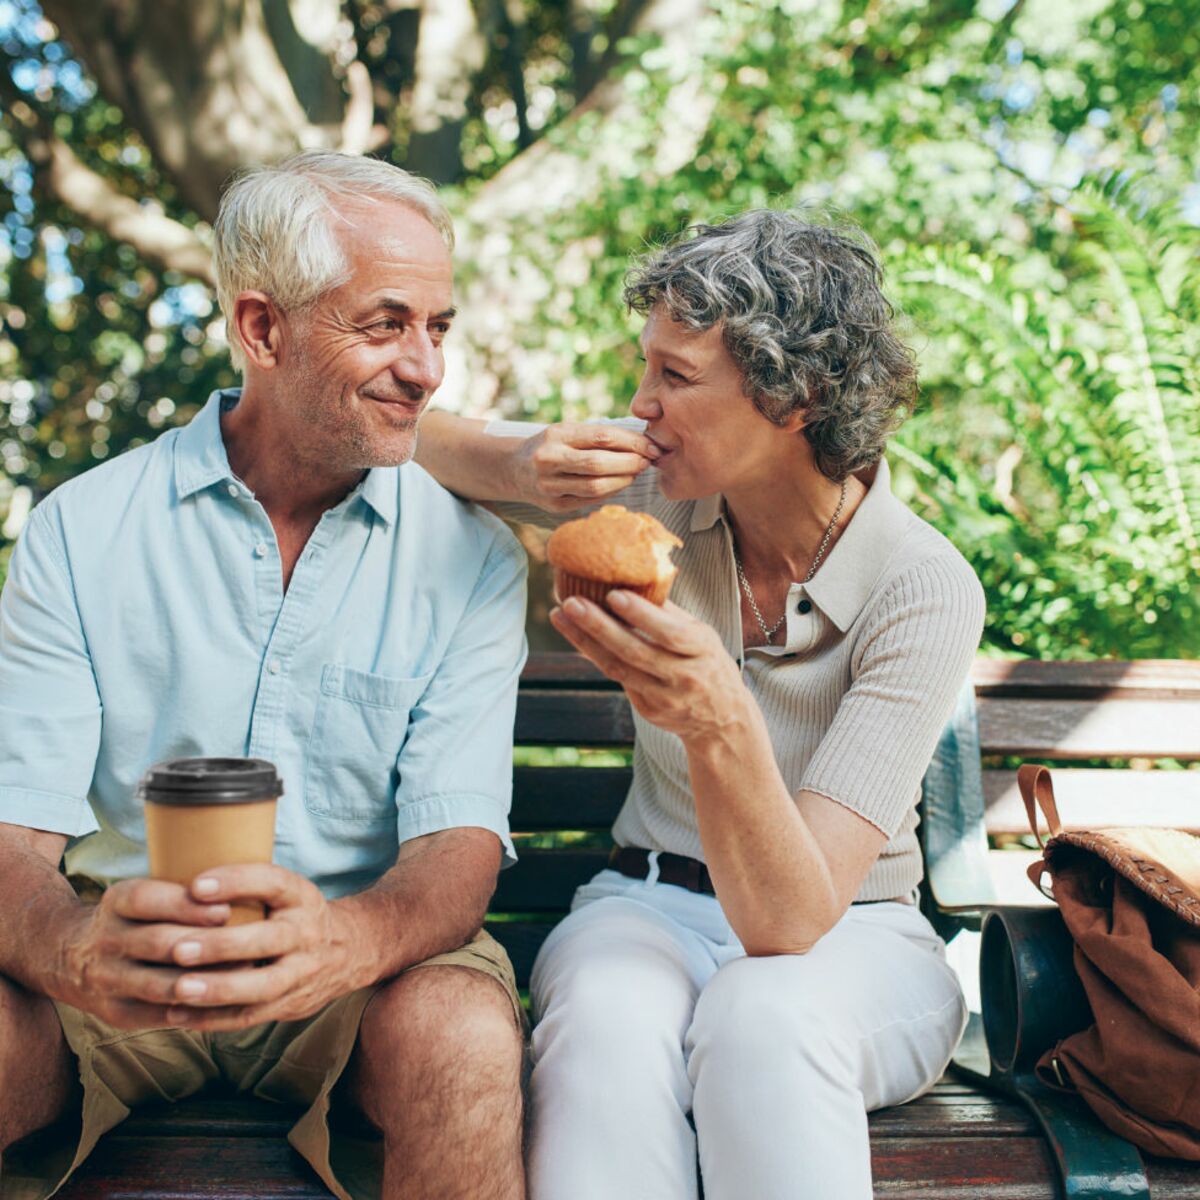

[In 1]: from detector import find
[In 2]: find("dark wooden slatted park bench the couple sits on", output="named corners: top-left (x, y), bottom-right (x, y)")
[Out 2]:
top-left (51, 654), bottom-right (1200, 1200)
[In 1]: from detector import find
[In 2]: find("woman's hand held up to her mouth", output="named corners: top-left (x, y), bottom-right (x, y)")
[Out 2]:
top-left (514, 424), bottom-right (659, 512)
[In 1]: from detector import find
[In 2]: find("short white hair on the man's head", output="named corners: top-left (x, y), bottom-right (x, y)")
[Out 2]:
top-left (212, 150), bottom-right (454, 368)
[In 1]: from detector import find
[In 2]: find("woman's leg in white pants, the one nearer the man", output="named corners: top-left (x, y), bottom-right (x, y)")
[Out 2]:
top-left (529, 896), bottom-right (710, 1200)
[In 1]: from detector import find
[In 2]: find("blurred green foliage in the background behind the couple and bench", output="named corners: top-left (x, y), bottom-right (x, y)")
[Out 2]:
top-left (0, 0), bottom-right (1200, 658)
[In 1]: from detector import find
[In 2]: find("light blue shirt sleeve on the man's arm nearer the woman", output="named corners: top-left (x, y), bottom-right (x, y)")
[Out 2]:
top-left (396, 527), bottom-right (527, 866)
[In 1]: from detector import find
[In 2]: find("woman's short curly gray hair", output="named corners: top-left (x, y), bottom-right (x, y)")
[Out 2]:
top-left (625, 209), bottom-right (917, 481)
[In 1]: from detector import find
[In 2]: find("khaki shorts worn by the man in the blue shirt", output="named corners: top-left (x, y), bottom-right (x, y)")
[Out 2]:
top-left (0, 931), bottom-right (526, 1200)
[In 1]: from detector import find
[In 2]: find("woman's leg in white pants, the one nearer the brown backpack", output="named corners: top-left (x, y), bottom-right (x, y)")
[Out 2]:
top-left (686, 904), bottom-right (966, 1200)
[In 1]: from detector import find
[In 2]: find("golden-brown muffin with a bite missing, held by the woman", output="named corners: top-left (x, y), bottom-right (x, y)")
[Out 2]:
top-left (546, 504), bottom-right (683, 605)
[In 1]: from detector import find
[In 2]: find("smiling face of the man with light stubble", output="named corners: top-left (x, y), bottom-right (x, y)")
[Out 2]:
top-left (277, 200), bottom-right (454, 470)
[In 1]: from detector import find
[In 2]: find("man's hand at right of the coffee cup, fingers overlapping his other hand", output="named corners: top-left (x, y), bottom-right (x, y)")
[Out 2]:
top-left (154, 864), bottom-right (360, 1031)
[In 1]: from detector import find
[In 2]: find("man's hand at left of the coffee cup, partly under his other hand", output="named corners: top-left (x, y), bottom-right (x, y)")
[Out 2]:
top-left (55, 880), bottom-right (236, 1030)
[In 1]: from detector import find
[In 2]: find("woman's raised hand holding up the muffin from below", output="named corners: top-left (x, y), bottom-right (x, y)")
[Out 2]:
top-left (550, 589), bottom-right (756, 745)
